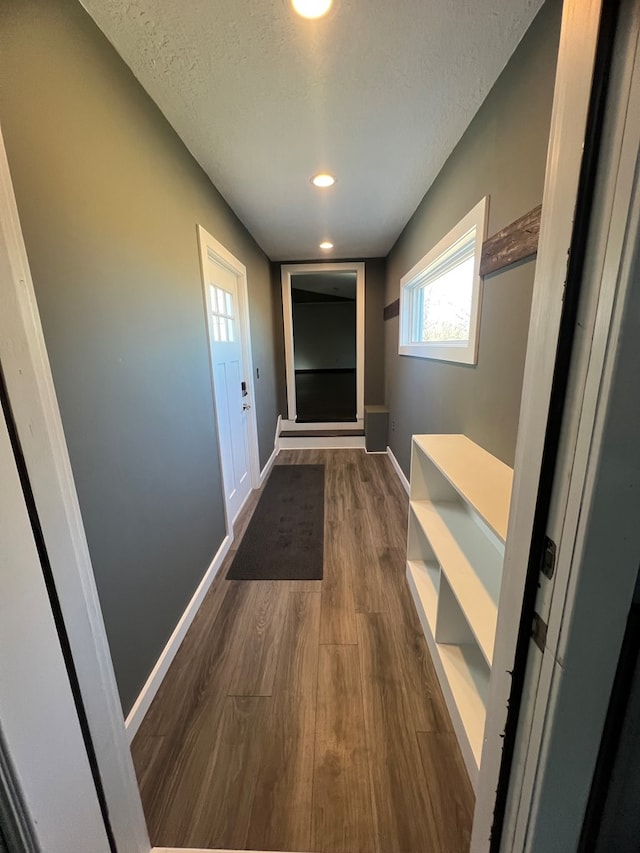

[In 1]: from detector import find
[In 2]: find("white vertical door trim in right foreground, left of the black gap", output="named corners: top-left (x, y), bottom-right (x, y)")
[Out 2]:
top-left (471, 0), bottom-right (601, 853)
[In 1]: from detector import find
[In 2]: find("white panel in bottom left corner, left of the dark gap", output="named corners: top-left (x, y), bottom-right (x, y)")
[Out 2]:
top-left (0, 400), bottom-right (109, 853)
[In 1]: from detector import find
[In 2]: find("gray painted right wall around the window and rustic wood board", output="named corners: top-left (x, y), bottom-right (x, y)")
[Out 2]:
top-left (385, 0), bottom-right (561, 475)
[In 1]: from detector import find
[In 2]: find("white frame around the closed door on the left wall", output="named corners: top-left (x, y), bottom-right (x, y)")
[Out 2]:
top-left (197, 225), bottom-right (260, 528)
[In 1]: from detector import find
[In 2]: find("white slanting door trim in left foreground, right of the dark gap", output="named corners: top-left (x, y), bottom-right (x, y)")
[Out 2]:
top-left (0, 123), bottom-right (151, 853)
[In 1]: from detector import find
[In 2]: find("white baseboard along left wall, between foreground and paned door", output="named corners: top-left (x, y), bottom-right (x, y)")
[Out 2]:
top-left (124, 535), bottom-right (233, 743)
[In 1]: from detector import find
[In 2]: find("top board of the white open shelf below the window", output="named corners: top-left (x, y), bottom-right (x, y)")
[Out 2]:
top-left (413, 435), bottom-right (513, 542)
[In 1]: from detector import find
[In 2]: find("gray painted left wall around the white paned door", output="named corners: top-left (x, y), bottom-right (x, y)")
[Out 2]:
top-left (0, 0), bottom-right (277, 713)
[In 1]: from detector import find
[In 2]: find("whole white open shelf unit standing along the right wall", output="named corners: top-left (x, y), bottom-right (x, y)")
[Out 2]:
top-left (407, 435), bottom-right (513, 785)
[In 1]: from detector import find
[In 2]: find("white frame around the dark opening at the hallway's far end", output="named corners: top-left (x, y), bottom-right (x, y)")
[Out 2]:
top-left (280, 261), bottom-right (365, 421)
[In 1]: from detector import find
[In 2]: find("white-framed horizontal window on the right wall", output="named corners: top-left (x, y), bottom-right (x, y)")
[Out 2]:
top-left (398, 198), bottom-right (488, 364)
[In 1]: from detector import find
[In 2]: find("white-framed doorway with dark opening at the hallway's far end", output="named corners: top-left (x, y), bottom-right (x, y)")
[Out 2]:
top-left (282, 263), bottom-right (364, 424)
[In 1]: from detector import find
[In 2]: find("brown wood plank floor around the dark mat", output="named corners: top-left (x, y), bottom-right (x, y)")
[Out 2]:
top-left (132, 450), bottom-right (473, 853)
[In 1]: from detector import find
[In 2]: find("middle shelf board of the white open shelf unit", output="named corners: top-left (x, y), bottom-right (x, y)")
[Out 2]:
top-left (411, 501), bottom-right (502, 666)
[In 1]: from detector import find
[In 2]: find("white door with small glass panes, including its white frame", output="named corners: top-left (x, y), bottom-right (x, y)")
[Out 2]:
top-left (198, 226), bottom-right (259, 534)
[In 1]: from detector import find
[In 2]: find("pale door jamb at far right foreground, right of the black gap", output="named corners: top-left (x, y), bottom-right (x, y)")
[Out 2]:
top-left (505, 0), bottom-right (640, 850)
